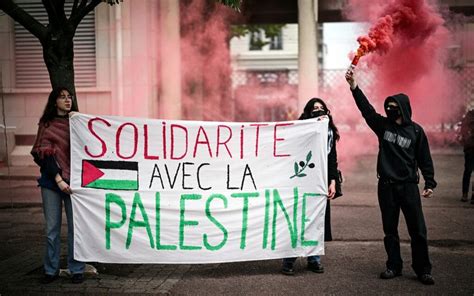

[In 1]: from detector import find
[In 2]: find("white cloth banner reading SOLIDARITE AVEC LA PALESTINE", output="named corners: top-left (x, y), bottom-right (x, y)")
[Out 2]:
top-left (70, 114), bottom-right (328, 263)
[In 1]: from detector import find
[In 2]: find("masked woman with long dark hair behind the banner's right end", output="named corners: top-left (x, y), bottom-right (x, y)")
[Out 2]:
top-left (281, 98), bottom-right (341, 275)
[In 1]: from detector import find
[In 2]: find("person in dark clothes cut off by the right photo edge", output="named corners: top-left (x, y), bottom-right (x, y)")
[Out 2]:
top-left (461, 110), bottom-right (474, 204)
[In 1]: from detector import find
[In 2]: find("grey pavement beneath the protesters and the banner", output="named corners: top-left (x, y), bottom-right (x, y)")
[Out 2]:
top-left (0, 151), bottom-right (474, 296)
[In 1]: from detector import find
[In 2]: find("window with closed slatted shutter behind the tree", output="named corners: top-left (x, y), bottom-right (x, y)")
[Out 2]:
top-left (14, 1), bottom-right (96, 88)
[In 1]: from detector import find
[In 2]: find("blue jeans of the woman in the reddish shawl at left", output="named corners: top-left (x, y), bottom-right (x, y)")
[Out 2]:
top-left (41, 187), bottom-right (85, 275)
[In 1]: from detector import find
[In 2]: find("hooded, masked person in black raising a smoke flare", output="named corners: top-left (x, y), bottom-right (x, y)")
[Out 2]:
top-left (346, 70), bottom-right (436, 285)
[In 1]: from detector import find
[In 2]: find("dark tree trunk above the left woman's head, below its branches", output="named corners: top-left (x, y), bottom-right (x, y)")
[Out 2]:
top-left (42, 27), bottom-right (77, 108)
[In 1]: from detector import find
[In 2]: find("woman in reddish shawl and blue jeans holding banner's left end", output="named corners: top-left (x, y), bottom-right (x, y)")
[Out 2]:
top-left (31, 87), bottom-right (85, 284)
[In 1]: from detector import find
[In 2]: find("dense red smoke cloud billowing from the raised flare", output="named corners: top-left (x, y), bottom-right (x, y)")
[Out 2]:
top-left (346, 0), bottom-right (463, 124)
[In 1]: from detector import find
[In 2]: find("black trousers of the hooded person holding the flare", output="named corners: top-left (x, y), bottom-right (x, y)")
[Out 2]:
top-left (378, 180), bottom-right (431, 275)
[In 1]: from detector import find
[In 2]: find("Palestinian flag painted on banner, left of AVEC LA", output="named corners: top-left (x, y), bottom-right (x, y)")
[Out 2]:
top-left (81, 159), bottom-right (138, 190)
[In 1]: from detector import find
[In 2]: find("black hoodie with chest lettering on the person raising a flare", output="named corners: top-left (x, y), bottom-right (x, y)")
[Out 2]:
top-left (352, 87), bottom-right (436, 189)
